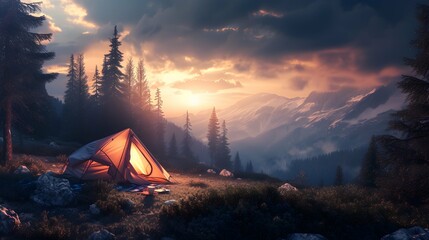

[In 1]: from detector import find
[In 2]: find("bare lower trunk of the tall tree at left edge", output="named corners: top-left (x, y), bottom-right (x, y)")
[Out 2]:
top-left (1, 97), bottom-right (12, 165)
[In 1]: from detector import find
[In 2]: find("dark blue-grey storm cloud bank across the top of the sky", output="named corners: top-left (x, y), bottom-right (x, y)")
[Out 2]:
top-left (76, 0), bottom-right (417, 71)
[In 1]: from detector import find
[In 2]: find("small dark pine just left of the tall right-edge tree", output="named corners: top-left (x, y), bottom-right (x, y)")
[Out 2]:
top-left (359, 137), bottom-right (379, 187)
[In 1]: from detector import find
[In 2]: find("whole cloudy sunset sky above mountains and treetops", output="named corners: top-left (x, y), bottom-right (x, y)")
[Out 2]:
top-left (30, 0), bottom-right (427, 118)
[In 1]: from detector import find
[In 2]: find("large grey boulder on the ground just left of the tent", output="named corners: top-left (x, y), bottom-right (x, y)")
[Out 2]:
top-left (31, 172), bottom-right (74, 206)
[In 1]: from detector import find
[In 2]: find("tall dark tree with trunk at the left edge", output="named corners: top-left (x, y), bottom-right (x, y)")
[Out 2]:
top-left (0, 0), bottom-right (56, 164)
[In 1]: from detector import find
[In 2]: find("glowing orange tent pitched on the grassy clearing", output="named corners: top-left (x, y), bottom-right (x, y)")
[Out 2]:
top-left (63, 128), bottom-right (170, 184)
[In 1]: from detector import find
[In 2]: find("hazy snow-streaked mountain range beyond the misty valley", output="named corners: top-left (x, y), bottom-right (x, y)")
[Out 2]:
top-left (169, 83), bottom-right (405, 172)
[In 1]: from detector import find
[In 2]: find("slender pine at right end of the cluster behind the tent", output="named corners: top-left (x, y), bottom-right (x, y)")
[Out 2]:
top-left (155, 88), bottom-right (165, 158)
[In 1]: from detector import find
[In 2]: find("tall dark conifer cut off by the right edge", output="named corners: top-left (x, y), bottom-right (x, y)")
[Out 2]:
top-left (379, 4), bottom-right (429, 204)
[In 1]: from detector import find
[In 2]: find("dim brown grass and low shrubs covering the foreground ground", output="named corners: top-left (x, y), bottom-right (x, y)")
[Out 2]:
top-left (0, 155), bottom-right (429, 239)
